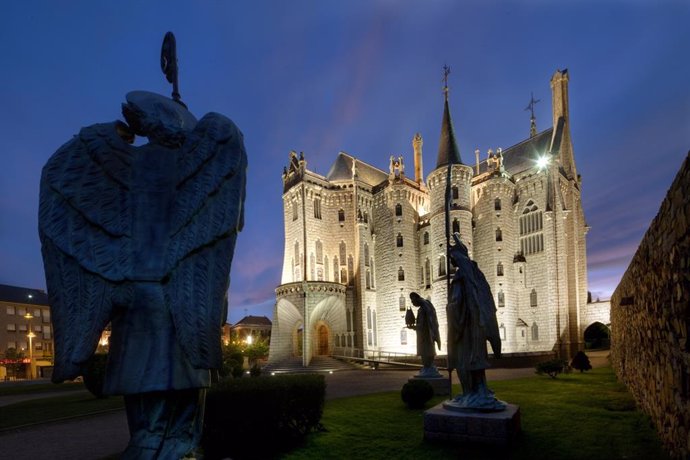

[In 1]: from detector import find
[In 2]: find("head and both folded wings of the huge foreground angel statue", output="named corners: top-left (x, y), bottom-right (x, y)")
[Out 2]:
top-left (39, 92), bottom-right (247, 382)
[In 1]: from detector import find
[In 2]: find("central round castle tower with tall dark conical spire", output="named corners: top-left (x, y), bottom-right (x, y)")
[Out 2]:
top-left (427, 73), bottom-right (473, 337)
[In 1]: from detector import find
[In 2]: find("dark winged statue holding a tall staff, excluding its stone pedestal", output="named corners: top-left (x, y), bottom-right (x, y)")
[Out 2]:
top-left (444, 233), bottom-right (506, 411)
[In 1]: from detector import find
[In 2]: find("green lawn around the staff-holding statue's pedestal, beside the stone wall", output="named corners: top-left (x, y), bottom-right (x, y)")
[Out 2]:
top-left (286, 368), bottom-right (668, 460)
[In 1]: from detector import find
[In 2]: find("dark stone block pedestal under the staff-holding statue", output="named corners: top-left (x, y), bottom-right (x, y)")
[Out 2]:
top-left (424, 403), bottom-right (520, 445)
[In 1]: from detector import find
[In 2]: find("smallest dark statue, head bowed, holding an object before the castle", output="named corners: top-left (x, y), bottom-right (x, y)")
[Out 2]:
top-left (408, 292), bottom-right (441, 377)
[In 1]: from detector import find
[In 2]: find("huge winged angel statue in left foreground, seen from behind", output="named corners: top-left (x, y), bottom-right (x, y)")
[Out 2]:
top-left (39, 91), bottom-right (247, 458)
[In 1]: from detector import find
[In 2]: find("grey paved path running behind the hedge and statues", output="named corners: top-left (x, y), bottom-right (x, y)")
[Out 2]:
top-left (0, 352), bottom-right (608, 460)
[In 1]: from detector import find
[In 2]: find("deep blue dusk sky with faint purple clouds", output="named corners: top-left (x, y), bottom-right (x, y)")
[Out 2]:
top-left (0, 0), bottom-right (690, 323)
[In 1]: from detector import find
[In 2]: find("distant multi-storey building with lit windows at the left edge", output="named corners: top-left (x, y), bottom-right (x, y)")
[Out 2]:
top-left (0, 284), bottom-right (53, 380)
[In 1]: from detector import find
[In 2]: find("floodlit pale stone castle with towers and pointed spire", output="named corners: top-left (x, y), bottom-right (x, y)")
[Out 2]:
top-left (269, 71), bottom-right (588, 365)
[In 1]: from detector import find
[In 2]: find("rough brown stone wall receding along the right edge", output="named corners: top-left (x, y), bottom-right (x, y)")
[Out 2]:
top-left (611, 154), bottom-right (690, 458)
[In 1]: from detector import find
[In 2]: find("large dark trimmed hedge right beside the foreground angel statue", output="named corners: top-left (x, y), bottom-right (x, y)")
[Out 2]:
top-left (202, 374), bottom-right (326, 459)
